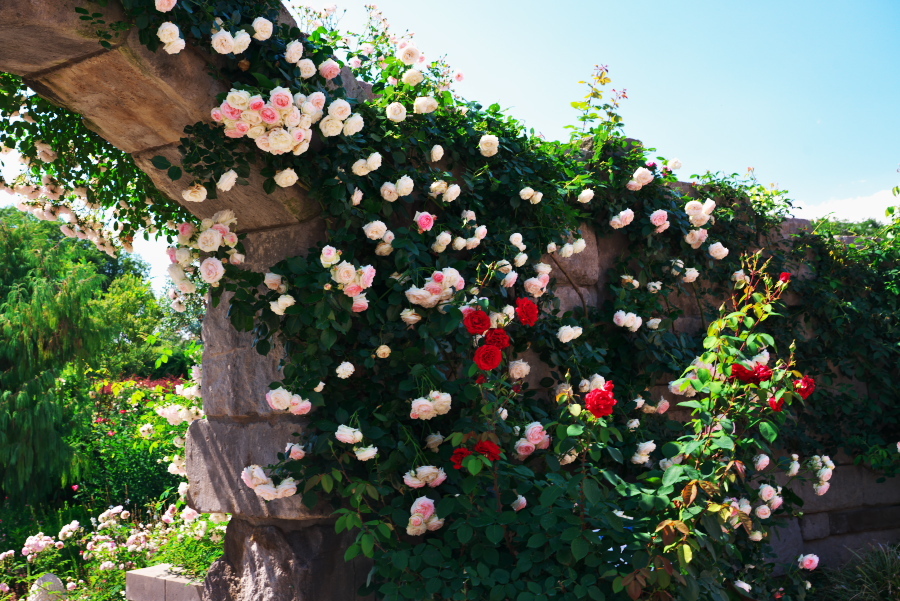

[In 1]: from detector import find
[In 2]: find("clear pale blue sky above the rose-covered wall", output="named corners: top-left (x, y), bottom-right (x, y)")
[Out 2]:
top-left (0, 0), bottom-right (900, 286)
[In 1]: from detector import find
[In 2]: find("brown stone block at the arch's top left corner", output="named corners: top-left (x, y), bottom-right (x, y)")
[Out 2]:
top-left (0, 0), bottom-right (125, 77)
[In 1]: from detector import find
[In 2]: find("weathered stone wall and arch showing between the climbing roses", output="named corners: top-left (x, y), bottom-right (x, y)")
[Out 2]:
top-left (0, 0), bottom-right (900, 601)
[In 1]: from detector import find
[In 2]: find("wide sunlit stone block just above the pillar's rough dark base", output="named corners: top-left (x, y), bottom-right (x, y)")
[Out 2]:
top-left (185, 418), bottom-right (331, 520)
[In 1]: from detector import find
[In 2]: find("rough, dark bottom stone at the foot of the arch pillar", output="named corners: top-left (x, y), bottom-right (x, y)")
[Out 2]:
top-left (203, 518), bottom-right (371, 601)
